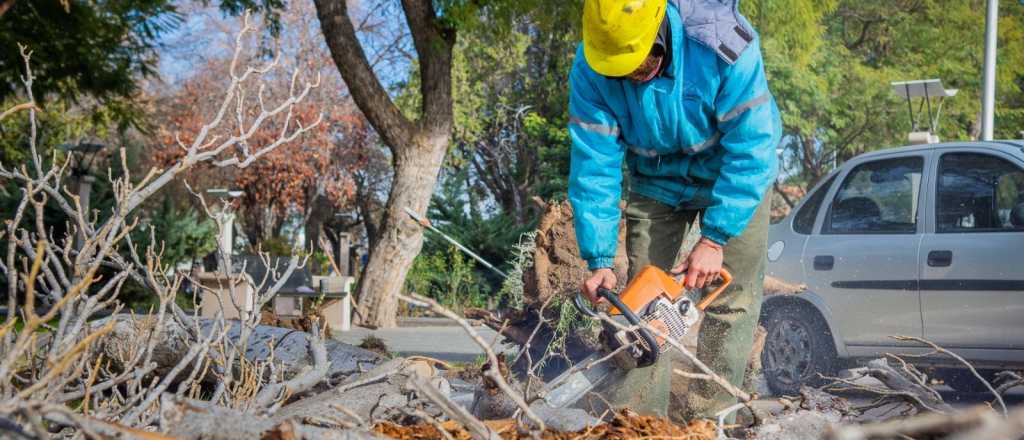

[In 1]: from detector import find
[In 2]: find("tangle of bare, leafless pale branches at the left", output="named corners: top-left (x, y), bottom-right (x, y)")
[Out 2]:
top-left (0, 17), bottom-right (329, 438)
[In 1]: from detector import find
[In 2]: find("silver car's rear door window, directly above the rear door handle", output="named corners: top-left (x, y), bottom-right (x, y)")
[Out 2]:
top-left (822, 156), bottom-right (925, 234)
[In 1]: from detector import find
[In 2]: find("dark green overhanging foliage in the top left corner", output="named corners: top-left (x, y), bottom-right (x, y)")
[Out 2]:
top-left (0, 0), bottom-right (285, 126)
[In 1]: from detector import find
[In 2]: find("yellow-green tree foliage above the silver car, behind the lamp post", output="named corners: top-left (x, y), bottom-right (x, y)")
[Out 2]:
top-left (742, 0), bottom-right (1024, 183)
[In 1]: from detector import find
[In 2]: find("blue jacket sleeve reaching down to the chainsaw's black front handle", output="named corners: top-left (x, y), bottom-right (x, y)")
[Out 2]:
top-left (568, 58), bottom-right (626, 270)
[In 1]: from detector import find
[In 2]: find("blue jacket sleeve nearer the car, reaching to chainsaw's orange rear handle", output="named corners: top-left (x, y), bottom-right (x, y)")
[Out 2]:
top-left (700, 35), bottom-right (782, 245)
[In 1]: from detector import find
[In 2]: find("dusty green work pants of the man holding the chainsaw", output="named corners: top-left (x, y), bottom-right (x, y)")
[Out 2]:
top-left (605, 194), bottom-right (770, 423)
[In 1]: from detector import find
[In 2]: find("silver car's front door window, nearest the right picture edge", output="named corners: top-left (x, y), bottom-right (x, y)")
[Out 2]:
top-left (935, 152), bottom-right (1024, 232)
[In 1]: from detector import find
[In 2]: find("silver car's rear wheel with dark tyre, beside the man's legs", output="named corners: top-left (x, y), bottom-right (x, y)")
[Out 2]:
top-left (761, 305), bottom-right (839, 396)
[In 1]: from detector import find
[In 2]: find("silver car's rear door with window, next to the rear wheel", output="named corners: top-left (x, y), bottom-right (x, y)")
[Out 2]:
top-left (804, 152), bottom-right (928, 347)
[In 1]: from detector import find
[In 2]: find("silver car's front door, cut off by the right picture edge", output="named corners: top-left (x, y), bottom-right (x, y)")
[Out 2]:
top-left (921, 148), bottom-right (1024, 349)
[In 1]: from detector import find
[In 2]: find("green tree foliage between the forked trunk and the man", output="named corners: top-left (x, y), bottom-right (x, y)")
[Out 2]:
top-left (446, 2), bottom-right (582, 224)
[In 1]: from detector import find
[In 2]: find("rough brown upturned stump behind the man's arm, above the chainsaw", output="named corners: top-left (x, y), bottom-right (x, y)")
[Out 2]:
top-left (523, 202), bottom-right (629, 305)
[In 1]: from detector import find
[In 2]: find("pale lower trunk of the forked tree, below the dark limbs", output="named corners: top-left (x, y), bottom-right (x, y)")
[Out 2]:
top-left (358, 137), bottom-right (447, 327)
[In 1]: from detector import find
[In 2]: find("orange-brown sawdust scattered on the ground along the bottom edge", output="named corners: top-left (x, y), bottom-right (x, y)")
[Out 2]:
top-left (374, 409), bottom-right (717, 440)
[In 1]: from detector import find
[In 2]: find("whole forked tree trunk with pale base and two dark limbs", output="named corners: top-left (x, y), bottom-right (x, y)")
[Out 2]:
top-left (314, 0), bottom-right (455, 327)
